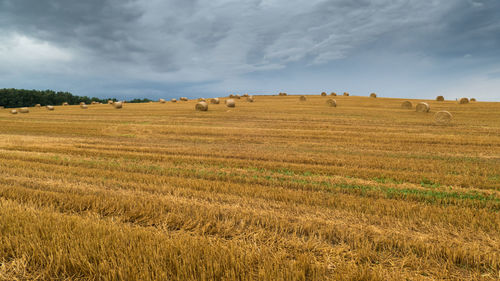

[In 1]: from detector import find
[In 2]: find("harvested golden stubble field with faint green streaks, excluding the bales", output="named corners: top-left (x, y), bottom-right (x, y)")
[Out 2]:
top-left (0, 95), bottom-right (500, 280)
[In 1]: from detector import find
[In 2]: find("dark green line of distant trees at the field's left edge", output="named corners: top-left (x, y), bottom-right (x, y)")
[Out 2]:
top-left (0, 89), bottom-right (116, 108)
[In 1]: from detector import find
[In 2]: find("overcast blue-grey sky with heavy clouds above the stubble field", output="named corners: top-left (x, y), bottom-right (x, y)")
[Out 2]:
top-left (0, 0), bottom-right (500, 101)
